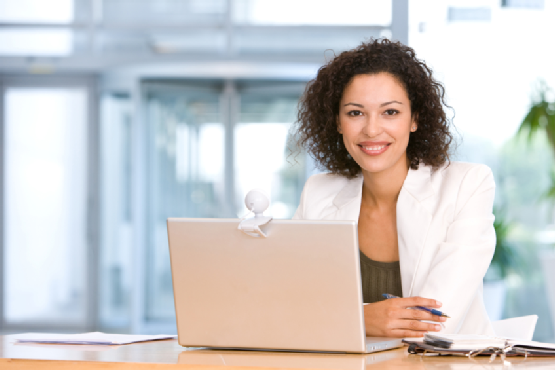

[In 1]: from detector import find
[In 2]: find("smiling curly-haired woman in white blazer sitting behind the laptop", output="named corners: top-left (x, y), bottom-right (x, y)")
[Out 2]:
top-left (294, 39), bottom-right (495, 337)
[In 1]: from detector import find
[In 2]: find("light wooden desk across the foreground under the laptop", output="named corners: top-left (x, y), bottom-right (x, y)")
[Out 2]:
top-left (0, 335), bottom-right (555, 370)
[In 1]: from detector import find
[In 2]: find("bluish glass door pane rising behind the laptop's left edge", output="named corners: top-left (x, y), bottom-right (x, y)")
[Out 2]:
top-left (143, 82), bottom-right (226, 324)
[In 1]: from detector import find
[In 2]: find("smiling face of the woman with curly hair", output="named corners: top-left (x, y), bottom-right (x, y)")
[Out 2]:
top-left (338, 73), bottom-right (417, 177)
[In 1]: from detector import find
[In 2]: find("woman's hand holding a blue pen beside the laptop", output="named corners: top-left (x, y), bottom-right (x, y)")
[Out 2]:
top-left (364, 297), bottom-right (446, 337)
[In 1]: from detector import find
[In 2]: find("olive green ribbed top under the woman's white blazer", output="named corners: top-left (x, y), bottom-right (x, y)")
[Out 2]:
top-left (360, 252), bottom-right (403, 303)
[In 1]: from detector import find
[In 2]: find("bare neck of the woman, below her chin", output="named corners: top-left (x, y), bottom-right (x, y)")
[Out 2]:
top-left (362, 156), bottom-right (409, 209)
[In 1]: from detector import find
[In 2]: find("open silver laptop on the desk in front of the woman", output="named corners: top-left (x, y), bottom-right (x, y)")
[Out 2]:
top-left (167, 218), bottom-right (403, 353)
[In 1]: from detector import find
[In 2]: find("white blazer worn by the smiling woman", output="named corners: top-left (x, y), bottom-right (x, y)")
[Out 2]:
top-left (293, 162), bottom-right (496, 335)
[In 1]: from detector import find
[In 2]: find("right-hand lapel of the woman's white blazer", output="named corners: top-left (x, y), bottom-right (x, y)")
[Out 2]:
top-left (397, 164), bottom-right (435, 297)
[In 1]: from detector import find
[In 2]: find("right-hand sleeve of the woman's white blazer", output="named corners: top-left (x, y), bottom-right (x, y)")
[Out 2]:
top-left (415, 166), bottom-right (496, 333)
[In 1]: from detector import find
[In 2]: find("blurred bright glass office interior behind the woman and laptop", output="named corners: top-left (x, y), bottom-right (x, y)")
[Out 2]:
top-left (0, 0), bottom-right (555, 341)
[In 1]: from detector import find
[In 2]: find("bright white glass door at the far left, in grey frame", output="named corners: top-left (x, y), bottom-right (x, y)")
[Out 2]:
top-left (0, 80), bottom-right (93, 328)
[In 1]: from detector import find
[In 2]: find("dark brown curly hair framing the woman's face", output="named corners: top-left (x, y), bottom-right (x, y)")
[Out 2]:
top-left (294, 39), bottom-right (453, 178)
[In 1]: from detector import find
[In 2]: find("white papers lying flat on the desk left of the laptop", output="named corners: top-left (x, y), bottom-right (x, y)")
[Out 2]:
top-left (11, 332), bottom-right (177, 345)
